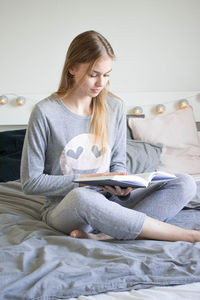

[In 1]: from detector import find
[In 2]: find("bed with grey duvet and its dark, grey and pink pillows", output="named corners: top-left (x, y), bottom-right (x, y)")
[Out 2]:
top-left (0, 92), bottom-right (200, 300)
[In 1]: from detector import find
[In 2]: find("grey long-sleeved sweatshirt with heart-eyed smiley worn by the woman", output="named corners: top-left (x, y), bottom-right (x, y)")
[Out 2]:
top-left (21, 95), bottom-right (126, 208)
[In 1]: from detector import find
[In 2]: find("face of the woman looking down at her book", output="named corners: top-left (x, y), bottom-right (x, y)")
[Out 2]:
top-left (69, 56), bottom-right (113, 98)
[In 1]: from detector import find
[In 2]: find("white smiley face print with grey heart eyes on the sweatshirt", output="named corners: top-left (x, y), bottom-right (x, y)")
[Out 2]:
top-left (60, 133), bottom-right (111, 175)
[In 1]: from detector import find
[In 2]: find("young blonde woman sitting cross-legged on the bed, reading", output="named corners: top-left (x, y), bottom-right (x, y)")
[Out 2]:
top-left (21, 31), bottom-right (200, 242)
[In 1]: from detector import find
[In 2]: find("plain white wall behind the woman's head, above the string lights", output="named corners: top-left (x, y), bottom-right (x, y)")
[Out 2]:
top-left (0, 0), bottom-right (200, 123)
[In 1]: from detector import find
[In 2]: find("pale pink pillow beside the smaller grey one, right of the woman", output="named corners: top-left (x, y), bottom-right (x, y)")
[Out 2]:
top-left (128, 106), bottom-right (200, 174)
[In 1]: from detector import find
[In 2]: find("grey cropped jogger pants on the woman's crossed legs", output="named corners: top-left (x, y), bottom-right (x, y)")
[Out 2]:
top-left (46, 174), bottom-right (196, 239)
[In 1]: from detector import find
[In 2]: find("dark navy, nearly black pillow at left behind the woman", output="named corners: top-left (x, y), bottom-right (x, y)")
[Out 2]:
top-left (0, 129), bottom-right (26, 182)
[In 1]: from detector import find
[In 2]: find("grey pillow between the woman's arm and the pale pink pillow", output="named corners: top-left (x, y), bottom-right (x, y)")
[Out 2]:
top-left (126, 139), bottom-right (162, 174)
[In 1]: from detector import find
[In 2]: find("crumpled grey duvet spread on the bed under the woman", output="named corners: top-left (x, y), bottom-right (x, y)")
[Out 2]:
top-left (0, 181), bottom-right (200, 300)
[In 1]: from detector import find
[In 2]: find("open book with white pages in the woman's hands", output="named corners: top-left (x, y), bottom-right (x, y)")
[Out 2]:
top-left (74, 171), bottom-right (176, 188)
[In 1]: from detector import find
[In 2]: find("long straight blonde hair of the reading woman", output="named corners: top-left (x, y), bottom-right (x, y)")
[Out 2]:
top-left (56, 30), bottom-right (115, 154)
